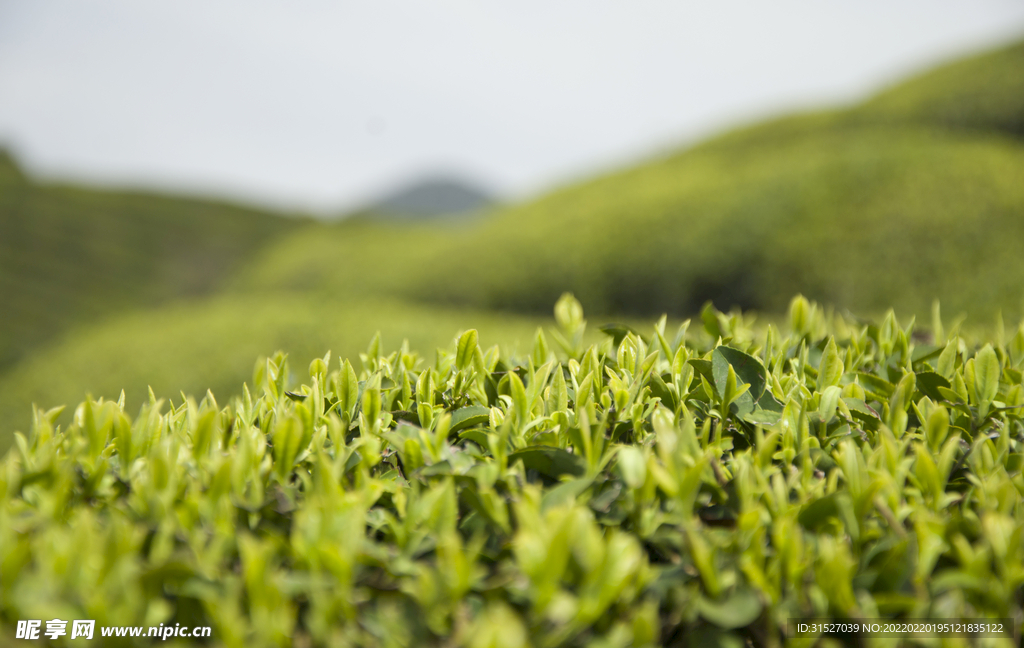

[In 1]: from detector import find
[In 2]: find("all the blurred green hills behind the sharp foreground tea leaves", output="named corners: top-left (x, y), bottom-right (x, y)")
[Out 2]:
top-left (0, 37), bottom-right (1024, 448)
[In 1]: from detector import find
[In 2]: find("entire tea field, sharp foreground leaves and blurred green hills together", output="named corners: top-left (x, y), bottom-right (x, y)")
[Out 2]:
top-left (0, 36), bottom-right (1024, 648)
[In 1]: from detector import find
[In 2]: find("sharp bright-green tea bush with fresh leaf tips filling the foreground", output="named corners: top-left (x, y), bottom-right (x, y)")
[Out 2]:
top-left (0, 296), bottom-right (1024, 647)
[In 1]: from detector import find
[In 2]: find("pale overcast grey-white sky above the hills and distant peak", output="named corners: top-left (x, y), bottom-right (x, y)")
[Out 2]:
top-left (0, 0), bottom-right (1024, 214)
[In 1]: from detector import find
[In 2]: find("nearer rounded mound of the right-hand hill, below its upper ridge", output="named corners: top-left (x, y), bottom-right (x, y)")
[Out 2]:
top-left (410, 128), bottom-right (1024, 313)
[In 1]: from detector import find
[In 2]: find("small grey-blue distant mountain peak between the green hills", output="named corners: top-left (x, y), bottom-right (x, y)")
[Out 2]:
top-left (361, 175), bottom-right (496, 217)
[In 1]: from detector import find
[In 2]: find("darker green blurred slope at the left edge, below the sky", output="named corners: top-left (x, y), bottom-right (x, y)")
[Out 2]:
top-left (0, 150), bottom-right (298, 368)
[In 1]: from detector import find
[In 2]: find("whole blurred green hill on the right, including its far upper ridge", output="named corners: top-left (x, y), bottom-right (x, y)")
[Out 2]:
top-left (230, 36), bottom-right (1024, 315)
